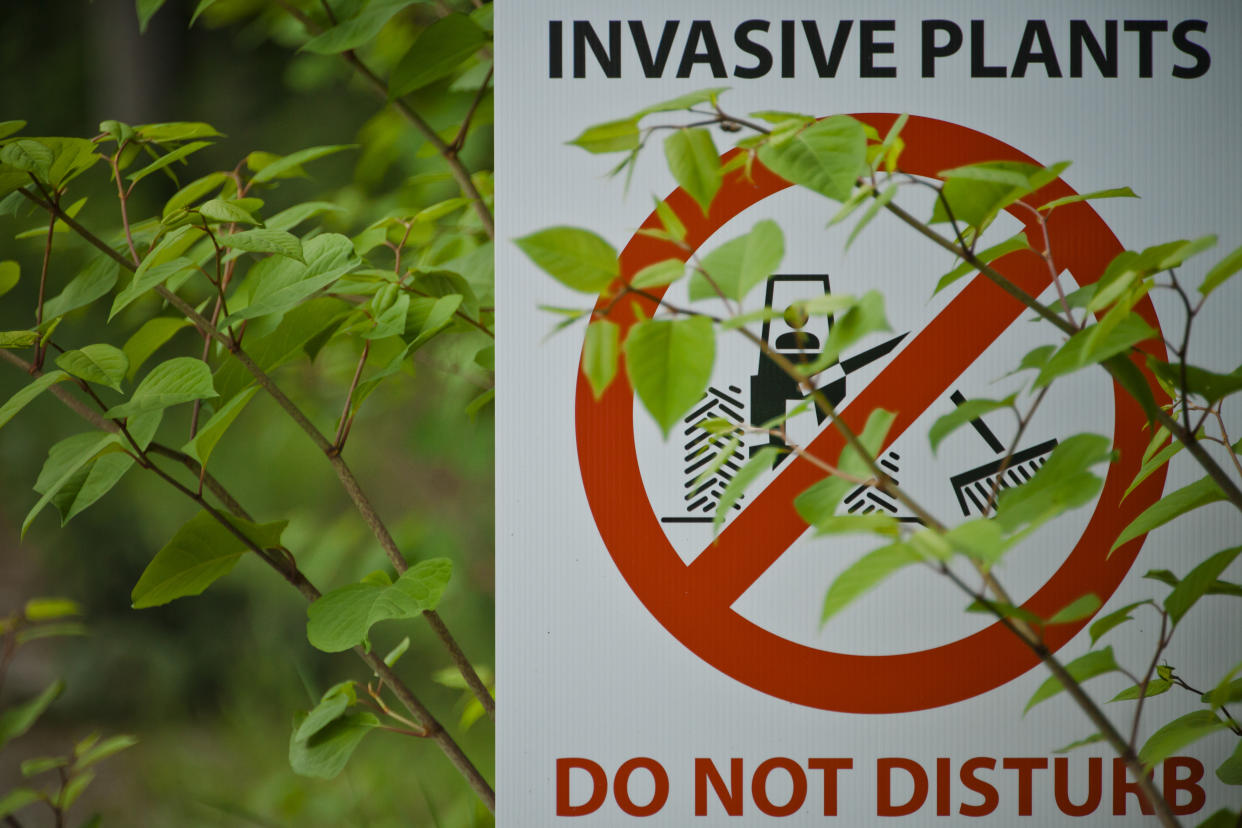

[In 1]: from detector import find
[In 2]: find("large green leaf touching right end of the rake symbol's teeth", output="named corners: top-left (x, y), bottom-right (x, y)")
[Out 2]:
top-left (996, 434), bottom-right (1113, 533)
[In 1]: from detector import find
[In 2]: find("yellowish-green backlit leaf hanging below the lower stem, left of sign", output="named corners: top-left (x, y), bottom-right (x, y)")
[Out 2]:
top-left (130, 510), bottom-right (288, 610)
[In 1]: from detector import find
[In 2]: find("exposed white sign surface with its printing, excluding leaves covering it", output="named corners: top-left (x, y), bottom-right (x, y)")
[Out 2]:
top-left (496, 0), bottom-right (1242, 828)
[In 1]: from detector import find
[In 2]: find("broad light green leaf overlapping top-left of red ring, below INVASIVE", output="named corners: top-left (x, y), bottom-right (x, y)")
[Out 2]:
top-left (759, 115), bottom-right (867, 201)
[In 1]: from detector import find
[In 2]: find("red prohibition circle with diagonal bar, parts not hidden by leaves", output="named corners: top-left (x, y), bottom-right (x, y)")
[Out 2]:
top-left (576, 114), bottom-right (1165, 714)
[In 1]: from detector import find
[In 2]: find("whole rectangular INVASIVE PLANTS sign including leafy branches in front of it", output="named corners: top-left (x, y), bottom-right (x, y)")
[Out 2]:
top-left (497, 0), bottom-right (1242, 827)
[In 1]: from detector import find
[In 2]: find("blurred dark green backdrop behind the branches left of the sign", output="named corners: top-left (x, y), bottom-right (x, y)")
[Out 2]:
top-left (0, 0), bottom-right (493, 827)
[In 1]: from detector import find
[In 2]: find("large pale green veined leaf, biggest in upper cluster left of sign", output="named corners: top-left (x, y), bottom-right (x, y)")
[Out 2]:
top-left (227, 233), bottom-right (359, 324)
